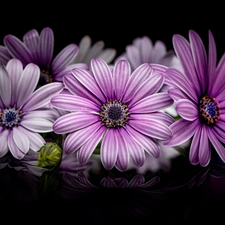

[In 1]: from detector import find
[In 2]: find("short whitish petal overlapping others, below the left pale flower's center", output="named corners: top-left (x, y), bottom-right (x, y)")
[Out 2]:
top-left (12, 126), bottom-right (30, 154)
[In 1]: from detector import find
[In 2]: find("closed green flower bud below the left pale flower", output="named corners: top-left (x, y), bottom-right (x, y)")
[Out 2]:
top-left (37, 142), bottom-right (62, 167)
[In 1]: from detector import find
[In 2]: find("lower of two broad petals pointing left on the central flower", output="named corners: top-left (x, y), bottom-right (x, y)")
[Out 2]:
top-left (53, 112), bottom-right (99, 134)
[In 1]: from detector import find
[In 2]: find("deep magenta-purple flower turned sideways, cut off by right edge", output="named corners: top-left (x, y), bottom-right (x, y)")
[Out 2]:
top-left (163, 30), bottom-right (225, 167)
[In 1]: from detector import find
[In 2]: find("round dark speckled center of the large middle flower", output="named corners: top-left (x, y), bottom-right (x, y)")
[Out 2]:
top-left (100, 100), bottom-right (129, 128)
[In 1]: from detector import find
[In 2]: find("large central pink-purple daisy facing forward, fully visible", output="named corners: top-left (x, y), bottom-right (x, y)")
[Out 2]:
top-left (51, 58), bottom-right (174, 171)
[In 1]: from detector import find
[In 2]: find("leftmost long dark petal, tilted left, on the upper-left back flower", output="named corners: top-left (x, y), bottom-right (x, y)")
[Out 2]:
top-left (3, 34), bottom-right (33, 66)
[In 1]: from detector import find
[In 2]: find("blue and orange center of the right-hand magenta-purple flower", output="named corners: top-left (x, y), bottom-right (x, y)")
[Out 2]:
top-left (199, 96), bottom-right (220, 125)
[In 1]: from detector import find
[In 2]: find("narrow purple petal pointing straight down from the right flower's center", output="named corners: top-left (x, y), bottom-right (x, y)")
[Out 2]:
top-left (198, 126), bottom-right (211, 167)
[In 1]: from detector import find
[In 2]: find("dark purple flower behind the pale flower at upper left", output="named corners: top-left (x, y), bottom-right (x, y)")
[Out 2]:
top-left (0, 27), bottom-right (87, 86)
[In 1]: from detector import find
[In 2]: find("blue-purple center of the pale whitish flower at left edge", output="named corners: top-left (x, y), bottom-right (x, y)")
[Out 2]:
top-left (0, 108), bottom-right (22, 129)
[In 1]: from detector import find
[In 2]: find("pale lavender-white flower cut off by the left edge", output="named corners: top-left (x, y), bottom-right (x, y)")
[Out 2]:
top-left (0, 59), bottom-right (64, 159)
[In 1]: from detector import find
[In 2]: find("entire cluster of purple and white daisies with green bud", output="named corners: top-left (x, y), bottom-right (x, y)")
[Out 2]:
top-left (0, 27), bottom-right (225, 171)
